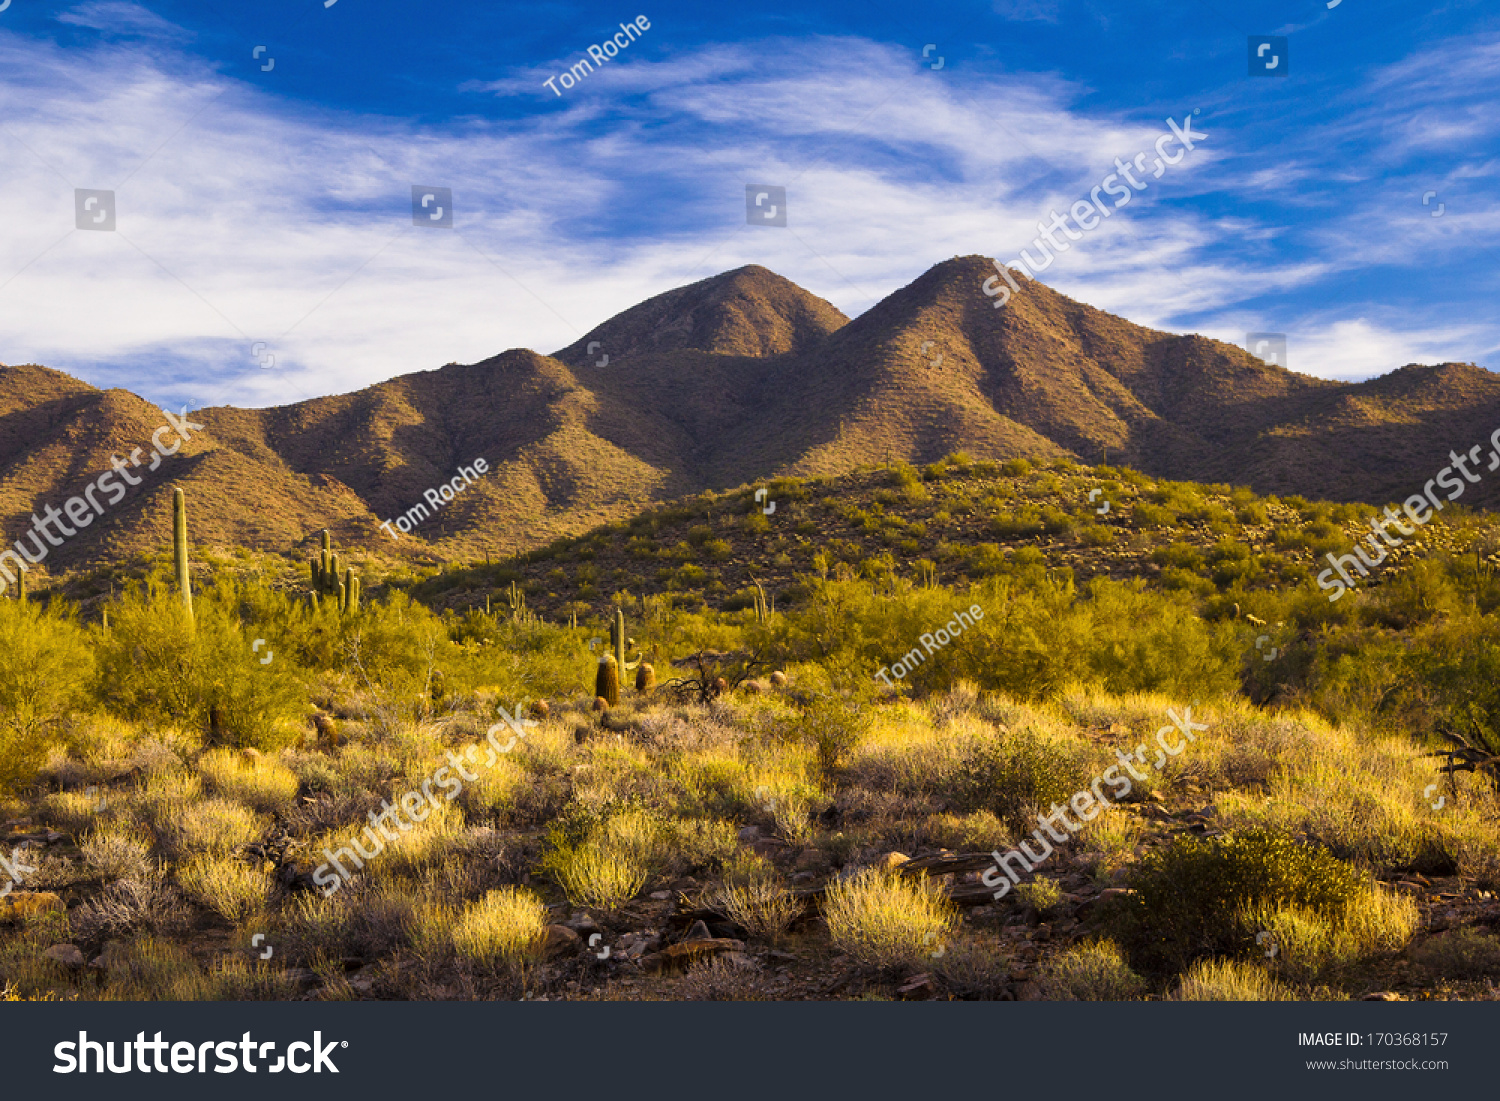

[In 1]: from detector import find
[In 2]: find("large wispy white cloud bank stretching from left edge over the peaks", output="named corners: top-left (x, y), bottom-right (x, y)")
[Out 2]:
top-left (0, 21), bottom-right (1478, 404)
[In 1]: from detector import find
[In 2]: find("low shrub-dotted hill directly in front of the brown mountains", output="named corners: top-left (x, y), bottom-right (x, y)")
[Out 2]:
top-left (414, 456), bottom-right (1457, 621)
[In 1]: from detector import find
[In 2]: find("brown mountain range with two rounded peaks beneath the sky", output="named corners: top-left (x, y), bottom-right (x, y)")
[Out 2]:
top-left (0, 257), bottom-right (1500, 567)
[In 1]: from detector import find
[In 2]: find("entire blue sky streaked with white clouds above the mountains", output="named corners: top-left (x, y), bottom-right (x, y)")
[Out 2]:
top-left (0, 0), bottom-right (1500, 407)
